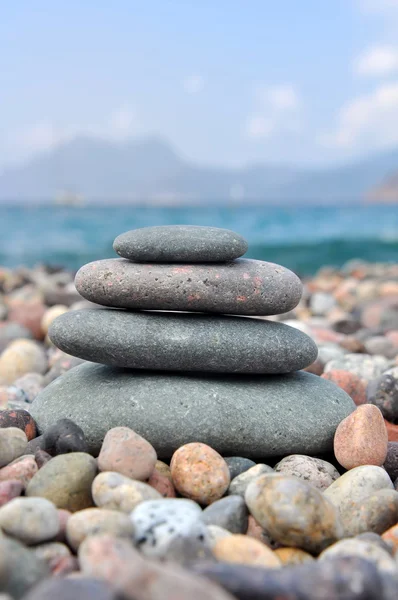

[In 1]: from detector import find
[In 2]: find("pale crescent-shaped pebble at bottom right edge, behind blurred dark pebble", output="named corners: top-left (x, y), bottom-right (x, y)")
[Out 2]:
top-left (318, 538), bottom-right (397, 575)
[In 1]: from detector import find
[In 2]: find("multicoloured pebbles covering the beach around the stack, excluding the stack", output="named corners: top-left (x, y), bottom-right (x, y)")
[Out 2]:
top-left (0, 261), bottom-right (398, 600)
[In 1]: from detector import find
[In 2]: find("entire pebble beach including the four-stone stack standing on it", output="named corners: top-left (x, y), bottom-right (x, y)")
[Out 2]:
top-left (0, 226), bottom-right (398, 600)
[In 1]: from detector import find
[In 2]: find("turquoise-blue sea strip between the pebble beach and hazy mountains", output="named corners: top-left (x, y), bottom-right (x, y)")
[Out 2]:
top-left (0, 205), bottom-right (398, 276)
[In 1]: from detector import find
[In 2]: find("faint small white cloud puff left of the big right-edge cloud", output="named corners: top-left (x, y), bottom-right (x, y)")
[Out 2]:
top-left (244, 83), bottom-right (300, 140)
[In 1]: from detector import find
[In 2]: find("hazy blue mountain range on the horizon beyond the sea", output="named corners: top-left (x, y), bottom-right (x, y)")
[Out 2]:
top-left (0, 138), bottom-right (398, 204)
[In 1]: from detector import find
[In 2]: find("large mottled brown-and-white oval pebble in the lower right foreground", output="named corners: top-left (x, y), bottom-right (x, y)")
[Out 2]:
top-left (245, 474), bottom-right (343, 553)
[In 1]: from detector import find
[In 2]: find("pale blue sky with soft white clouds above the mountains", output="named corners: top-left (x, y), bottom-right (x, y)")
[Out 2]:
top-left (0, 0), bottom-right (398, 169)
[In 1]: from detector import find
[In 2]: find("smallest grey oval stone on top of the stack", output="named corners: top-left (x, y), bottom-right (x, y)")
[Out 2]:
top-left (113, 225), bottom-right (248, 263)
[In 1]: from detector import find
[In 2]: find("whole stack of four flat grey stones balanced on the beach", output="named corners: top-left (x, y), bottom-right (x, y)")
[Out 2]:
top-left (31, 226), bottom-right (355, 458)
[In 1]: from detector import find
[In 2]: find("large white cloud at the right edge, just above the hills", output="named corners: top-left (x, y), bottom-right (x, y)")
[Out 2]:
top-left (318, 81), bottom-right (398, 150)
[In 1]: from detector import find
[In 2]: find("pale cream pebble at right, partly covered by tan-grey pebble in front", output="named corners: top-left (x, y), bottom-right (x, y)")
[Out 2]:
top-left (324, 465), bottom-right (394, 516)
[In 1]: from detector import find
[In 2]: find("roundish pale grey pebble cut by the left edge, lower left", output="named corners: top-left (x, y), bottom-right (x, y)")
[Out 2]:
top-left (0, 498), bottom-right (59, 545)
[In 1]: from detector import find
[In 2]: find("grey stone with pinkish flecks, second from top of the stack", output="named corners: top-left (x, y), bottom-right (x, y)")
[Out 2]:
top-left (75, 258), bottom-right (302, 316)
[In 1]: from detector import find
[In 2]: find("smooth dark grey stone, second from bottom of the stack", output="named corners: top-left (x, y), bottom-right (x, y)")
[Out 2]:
top-left (49, 308), bottom-right (318, 373)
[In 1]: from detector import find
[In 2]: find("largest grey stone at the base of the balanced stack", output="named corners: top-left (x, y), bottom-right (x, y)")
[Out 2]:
top-left (31, 363), bottom-right (355, 463)
